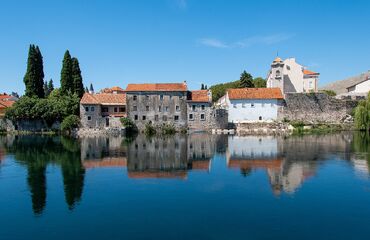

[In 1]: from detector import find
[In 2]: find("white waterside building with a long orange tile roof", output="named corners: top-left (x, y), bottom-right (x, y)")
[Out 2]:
top-left (219, 88), bottom-right (283, 123)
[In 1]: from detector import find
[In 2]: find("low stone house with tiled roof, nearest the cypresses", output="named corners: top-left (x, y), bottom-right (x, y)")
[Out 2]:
top-left (80, 93), bottom-right (126, 129)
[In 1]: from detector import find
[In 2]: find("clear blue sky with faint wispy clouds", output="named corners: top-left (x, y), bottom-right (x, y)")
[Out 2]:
top-left (0, 0), bottom-right (370, 94)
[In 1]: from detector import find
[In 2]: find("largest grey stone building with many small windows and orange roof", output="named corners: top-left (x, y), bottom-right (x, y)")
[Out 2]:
top-left (126, 82), bottom-right (188, 130)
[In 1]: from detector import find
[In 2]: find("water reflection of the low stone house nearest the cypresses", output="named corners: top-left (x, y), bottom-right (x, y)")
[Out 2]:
top-left (81, 136), bottom-right (127, 168)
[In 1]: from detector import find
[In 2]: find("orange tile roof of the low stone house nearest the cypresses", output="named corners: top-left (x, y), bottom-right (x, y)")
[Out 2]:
top-left (80, 93), bottom-right (126, 105)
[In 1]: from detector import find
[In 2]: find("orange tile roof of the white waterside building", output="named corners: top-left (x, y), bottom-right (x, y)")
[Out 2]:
top-left (227, 88), bottom-right (284, 100)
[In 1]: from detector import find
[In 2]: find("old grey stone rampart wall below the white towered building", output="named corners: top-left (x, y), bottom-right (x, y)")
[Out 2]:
top-left (278, 93), bottom-right (357, 124)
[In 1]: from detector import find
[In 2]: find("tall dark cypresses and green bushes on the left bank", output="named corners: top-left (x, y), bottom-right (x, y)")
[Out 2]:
top-left (6, 44), bottom-right (85, 124)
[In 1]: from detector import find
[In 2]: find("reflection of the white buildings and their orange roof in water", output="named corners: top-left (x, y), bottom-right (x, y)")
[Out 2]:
top-left (228, 136), bottom-right (316, 194)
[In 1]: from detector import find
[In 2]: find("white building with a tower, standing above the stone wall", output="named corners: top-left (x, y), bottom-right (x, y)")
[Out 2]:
top-left (266, 57), bottom-right (320, 94)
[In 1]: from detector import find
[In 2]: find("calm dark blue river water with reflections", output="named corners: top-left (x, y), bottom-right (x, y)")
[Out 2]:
top-left (0, 133), bottom-right (370, 240)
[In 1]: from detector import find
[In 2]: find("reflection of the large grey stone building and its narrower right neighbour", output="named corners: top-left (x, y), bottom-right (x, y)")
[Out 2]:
top-left (127, 133), bottom-right (220, 179)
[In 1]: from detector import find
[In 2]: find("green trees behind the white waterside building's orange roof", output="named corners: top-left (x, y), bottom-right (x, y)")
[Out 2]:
top-left (210, 71), bottom-right (266, 102)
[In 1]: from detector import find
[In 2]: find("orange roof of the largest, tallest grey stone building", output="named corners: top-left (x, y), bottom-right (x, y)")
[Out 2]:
top-left (126, 83), bottom-right (188, 92)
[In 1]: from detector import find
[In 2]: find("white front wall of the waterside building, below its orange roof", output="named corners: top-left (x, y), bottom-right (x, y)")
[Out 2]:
top-left (227, 95), bottom-right (278, 123)
